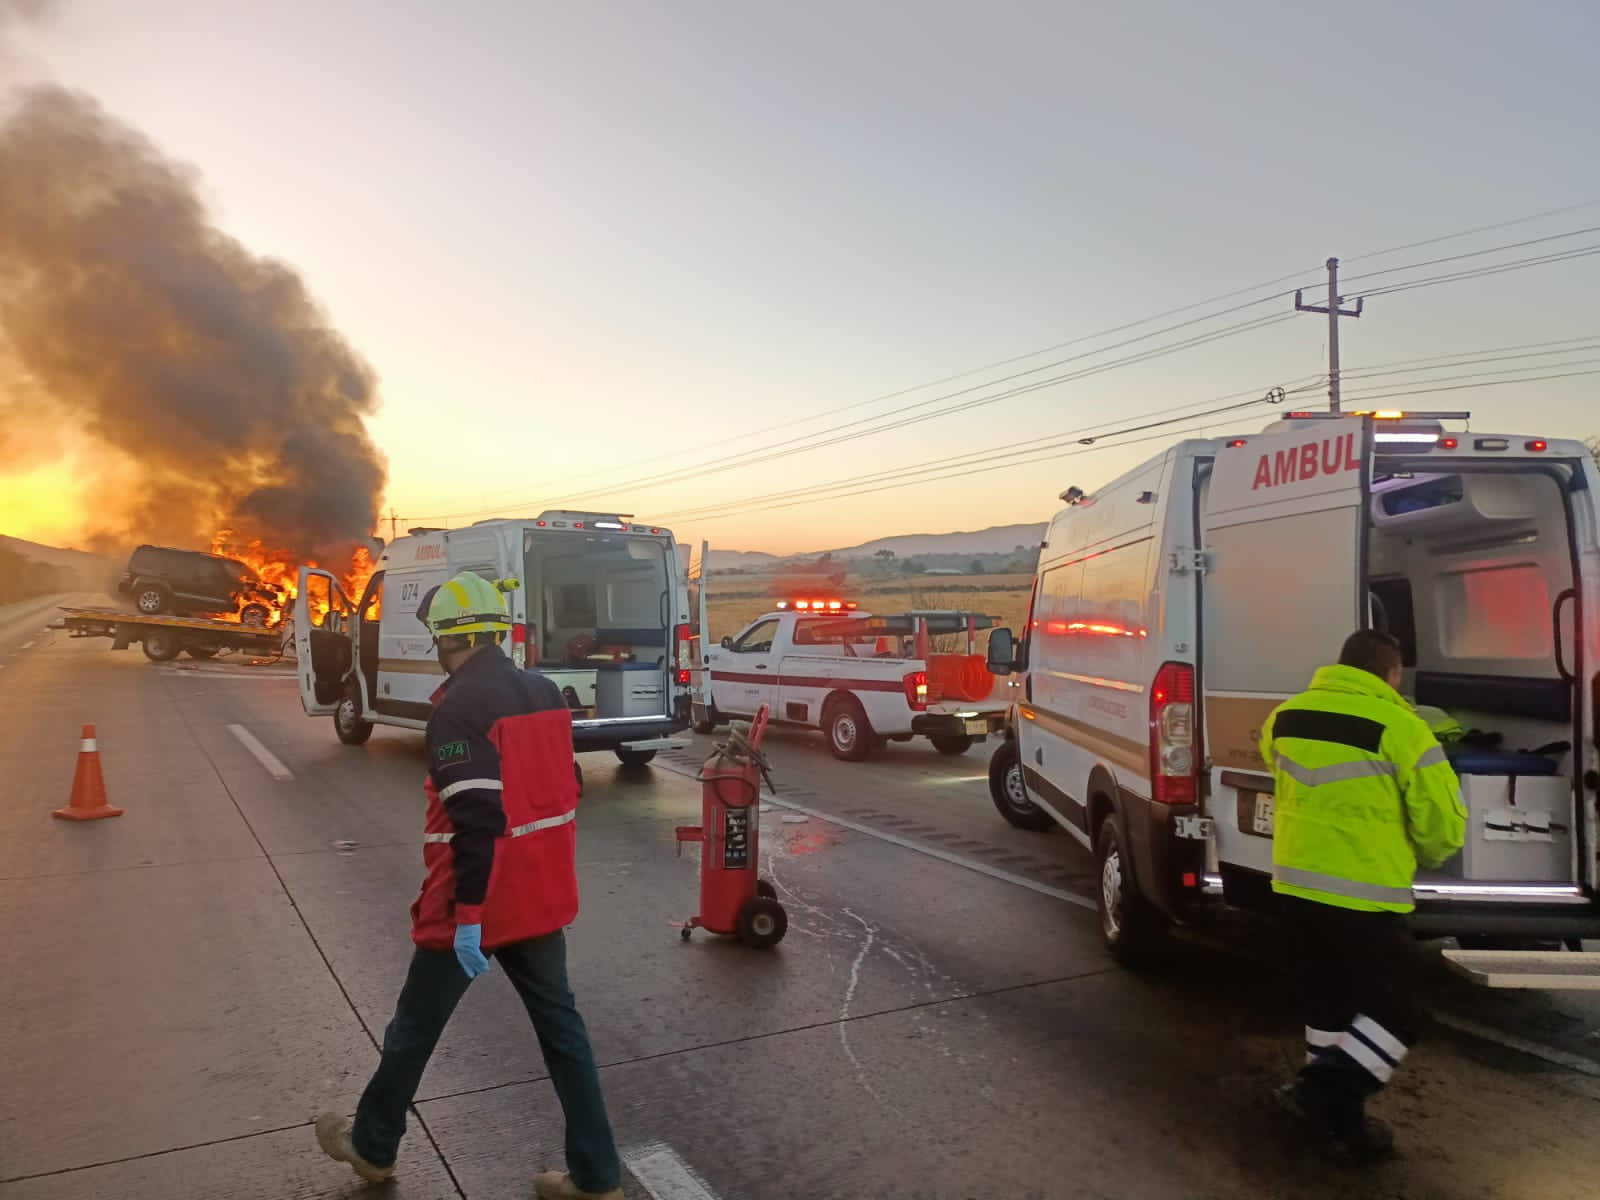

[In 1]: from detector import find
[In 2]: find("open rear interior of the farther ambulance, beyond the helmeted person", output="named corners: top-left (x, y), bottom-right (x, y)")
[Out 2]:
top-left (523, 531), bottom-right (672, 720)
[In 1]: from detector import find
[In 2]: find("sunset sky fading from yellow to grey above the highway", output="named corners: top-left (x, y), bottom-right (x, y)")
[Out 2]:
top-left (0, 0), bottom-right (1600, 552)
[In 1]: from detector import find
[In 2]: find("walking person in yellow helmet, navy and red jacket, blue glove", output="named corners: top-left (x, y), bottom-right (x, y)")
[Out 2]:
top-left (317, 571), bottom-right (622, 1200)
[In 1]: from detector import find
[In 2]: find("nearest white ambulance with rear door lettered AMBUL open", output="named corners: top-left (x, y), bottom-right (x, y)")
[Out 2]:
top-left (989, 413), bottom-right (1600, 985)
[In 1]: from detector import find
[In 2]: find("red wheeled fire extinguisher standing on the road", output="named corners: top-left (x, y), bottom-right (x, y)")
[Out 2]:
top-left (677, 704), bottom-right (789, 949)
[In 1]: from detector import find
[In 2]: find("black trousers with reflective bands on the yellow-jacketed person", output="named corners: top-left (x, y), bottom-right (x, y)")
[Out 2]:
top-left (1278, 896), bottom-right (1427, 1123)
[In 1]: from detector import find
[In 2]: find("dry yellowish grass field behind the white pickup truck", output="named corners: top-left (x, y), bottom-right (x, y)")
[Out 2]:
top-left (707, 574), bottom-right (1034, 642)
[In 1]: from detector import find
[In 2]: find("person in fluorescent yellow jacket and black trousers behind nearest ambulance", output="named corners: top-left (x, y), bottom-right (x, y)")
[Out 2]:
top-left (1261, 630), bottom-right (1467, 1160)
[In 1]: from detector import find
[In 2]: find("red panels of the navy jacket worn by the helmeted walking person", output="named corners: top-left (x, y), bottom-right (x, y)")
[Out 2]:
top-left (411, 709), bottom-right (578, 950)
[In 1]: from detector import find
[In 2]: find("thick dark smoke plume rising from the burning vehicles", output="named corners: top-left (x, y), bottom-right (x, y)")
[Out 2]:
top-left (0, 82), bottom-right (386, 557)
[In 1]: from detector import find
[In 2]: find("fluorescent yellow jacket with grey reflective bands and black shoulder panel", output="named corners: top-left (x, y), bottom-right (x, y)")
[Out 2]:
top-left (1261, 666), bottom-right (1467, 912)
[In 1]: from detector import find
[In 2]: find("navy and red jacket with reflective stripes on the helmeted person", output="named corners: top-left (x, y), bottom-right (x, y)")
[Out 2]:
top-left (411, 646), bottom-right (578, 950)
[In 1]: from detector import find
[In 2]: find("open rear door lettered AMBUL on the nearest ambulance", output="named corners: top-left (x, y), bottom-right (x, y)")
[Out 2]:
top-left (1197, 416), bottom-right (1373, 872)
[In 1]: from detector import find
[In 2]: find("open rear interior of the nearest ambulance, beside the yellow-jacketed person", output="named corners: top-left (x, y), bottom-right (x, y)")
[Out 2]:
top-left (1366, 470), bottom-right (1582, 885)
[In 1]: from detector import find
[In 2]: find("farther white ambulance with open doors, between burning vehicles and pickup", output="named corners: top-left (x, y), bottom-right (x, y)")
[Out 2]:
top-left (294, 512), bottom-right (690, 765)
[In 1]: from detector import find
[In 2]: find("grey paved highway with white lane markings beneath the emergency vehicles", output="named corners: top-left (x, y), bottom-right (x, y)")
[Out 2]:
top-left (0, 633), bottom-right (1600, 1200)
